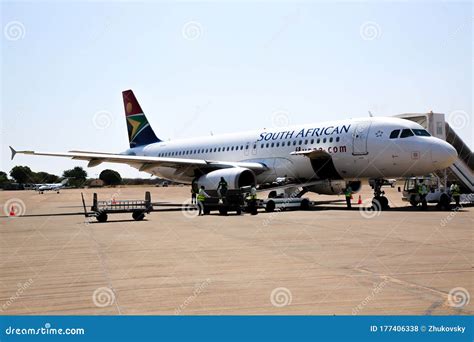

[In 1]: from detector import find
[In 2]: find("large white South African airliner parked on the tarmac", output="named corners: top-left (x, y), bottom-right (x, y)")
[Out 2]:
top-left (10, 90), bottom-right (457, 208)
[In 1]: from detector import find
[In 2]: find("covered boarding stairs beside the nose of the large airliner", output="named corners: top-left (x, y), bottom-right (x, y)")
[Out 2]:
top-left (397, 112), bottom-right (474, 193)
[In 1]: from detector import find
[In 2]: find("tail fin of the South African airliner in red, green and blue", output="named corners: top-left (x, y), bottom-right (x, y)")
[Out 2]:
top-left (122, 90), bottom-right (161, 147)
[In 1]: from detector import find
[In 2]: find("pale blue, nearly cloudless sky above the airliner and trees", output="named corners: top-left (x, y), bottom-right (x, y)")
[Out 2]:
top-left (0, 1), bottom-right (474, 177)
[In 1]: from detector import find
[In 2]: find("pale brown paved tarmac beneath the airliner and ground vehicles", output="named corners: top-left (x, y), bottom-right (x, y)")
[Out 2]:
top-left (0, 186), bottom-right (474, 315)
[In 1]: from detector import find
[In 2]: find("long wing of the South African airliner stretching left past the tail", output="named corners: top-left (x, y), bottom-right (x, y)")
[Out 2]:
top-left (10, 146), bottom-right (268, 174)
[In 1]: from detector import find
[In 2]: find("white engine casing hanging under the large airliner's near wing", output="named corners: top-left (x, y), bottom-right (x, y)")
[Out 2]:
top-left (197, 167), bottom-right (257, 190)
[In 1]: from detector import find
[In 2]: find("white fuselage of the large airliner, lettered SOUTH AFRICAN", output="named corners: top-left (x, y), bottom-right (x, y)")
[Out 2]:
top-left (124, 118), bottom-right (457, 187)
